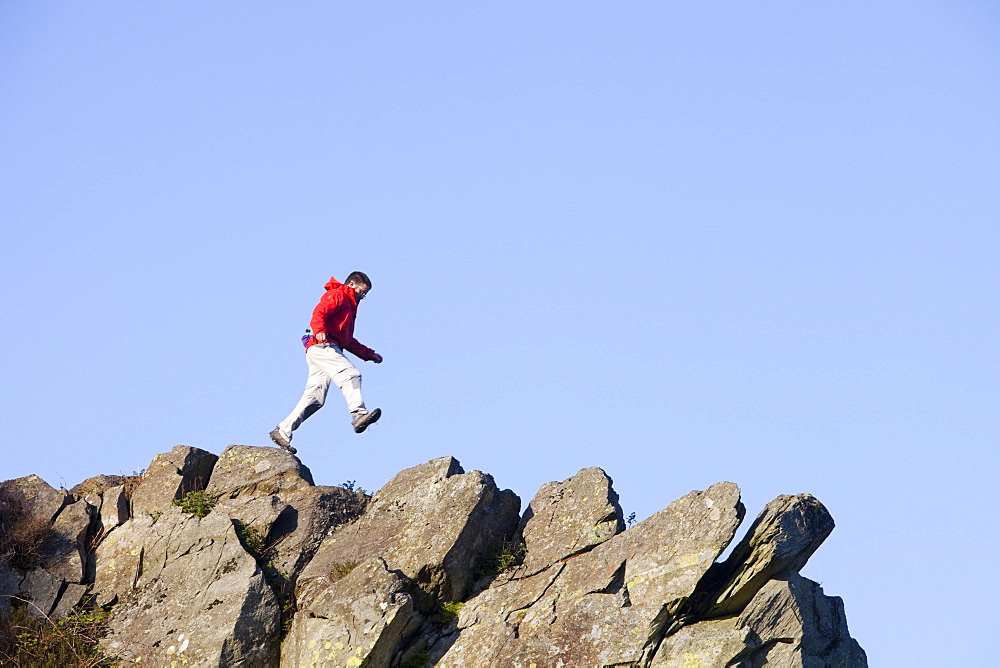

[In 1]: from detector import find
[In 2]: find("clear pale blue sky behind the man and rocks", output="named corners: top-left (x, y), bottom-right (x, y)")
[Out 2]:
top-left (0, 2), bottom-right (1000, 668)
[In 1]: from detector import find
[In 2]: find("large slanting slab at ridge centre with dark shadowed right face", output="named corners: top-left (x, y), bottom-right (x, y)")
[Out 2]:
top-left (299, 457), bottom-right (520, 601)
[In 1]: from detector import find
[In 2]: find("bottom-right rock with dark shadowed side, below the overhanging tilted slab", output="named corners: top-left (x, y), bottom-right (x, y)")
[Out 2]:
top-left (652, 573), bottom-right (868, 668)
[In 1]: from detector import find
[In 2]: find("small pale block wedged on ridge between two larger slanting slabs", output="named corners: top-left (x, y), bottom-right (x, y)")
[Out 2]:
top-left (520, 467), bottom-right (625, 575)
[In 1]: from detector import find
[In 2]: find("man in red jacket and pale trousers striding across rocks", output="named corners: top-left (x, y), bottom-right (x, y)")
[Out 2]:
top-left (270, 271), bottom-right (382, 454)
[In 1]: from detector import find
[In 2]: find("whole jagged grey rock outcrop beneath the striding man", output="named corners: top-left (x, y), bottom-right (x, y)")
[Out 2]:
top-left (0, 445), bottom-right (867, 668)
